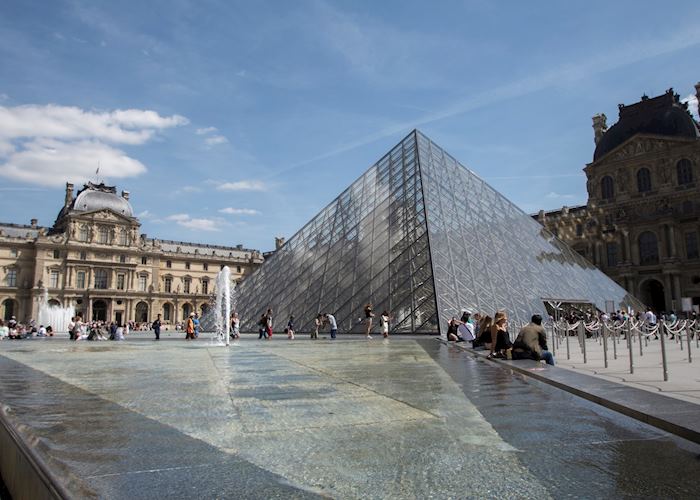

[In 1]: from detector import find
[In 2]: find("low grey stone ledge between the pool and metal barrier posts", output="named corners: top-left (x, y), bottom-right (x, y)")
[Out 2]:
top-left (436, 338), bottom-right (700, 444)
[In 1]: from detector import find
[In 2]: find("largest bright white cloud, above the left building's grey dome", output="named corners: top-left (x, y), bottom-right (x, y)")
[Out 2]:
top-left (0, 104), bottom-right (188, 186)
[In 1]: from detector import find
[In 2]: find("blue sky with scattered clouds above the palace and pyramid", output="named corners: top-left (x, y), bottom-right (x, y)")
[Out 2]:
top-left (0, 0), bottom-right (700, 250)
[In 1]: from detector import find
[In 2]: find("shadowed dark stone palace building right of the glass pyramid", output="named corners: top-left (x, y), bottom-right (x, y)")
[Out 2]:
top-left (533, 83), bottom-right (700, 312)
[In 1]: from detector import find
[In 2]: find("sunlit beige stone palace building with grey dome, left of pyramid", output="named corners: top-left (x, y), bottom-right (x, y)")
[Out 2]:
top-left (0, 183), bottom-right (263, 324)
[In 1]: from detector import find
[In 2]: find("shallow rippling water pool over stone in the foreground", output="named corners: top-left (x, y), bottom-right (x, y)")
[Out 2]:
top-left (0, 338), bottom-right (700, 498)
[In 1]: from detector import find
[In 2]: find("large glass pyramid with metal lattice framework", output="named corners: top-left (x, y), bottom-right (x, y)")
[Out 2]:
top-left (238, 131), bottom-right (639, 334)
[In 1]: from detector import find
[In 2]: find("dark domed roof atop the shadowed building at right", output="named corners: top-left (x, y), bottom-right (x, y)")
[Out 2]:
top-left (593, 89), bottom-right (700, 161)
